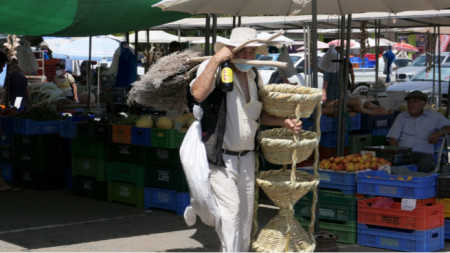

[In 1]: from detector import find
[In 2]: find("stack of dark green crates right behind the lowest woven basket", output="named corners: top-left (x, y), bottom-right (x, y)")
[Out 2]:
top-left (294, 189), bottom-right (357, 244)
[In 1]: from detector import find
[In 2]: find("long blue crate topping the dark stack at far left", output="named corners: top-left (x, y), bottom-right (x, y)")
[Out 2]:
top-left (14, 119), bottom-right (61, 135)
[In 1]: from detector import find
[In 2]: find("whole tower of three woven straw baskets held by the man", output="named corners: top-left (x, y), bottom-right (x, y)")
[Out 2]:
top-left (252, 84), bottom-right (322, 252)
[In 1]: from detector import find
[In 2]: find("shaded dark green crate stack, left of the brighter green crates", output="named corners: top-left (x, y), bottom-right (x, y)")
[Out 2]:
top-left (72, 123), bottom-right (111, 200)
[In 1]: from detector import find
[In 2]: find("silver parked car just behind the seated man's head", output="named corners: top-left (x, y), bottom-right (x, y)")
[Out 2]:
top-left (386, 65), bottom-right (450, 103)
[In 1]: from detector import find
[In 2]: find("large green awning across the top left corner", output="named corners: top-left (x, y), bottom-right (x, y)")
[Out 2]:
top-left (0, 0), bottom-right (189, 36)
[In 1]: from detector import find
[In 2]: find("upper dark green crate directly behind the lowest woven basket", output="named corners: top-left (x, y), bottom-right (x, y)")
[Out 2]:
top-left (294, 190), bottom-right (358, 222)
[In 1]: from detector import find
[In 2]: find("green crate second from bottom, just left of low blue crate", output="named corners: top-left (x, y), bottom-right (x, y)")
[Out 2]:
top-left (106, 162), bottom-right (146, 187)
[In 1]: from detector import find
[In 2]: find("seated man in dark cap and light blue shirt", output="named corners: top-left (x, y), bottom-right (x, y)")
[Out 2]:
top-left (387, 90), bottom-right (450, 172)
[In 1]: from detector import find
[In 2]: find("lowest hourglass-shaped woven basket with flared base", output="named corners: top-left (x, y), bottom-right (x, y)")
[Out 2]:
top-left (252, 169), bottom-right (319, 252)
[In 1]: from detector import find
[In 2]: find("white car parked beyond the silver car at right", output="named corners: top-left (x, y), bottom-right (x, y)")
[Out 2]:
top-left (395, 52), bottom-right (450, 81)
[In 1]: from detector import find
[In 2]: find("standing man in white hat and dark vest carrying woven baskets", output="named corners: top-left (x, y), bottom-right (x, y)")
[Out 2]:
top-left (191, 27), bottom-right (301, 252)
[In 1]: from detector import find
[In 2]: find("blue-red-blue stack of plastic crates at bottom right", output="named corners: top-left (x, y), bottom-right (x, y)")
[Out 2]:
top-left (357, 171), bottom-right (445, 252)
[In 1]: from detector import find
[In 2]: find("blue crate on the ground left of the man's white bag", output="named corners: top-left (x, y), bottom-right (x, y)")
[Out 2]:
top-left (144, 188), bottom-right (177, 212)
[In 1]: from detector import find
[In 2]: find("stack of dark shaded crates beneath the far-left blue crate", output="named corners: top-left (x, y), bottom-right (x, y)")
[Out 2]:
top-left (12, 134), bottom-right (65, 189)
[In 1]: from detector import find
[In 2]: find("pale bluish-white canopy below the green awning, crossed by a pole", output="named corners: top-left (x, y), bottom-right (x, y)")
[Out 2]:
top-left (52, 36), bottom-right (120, 61)
